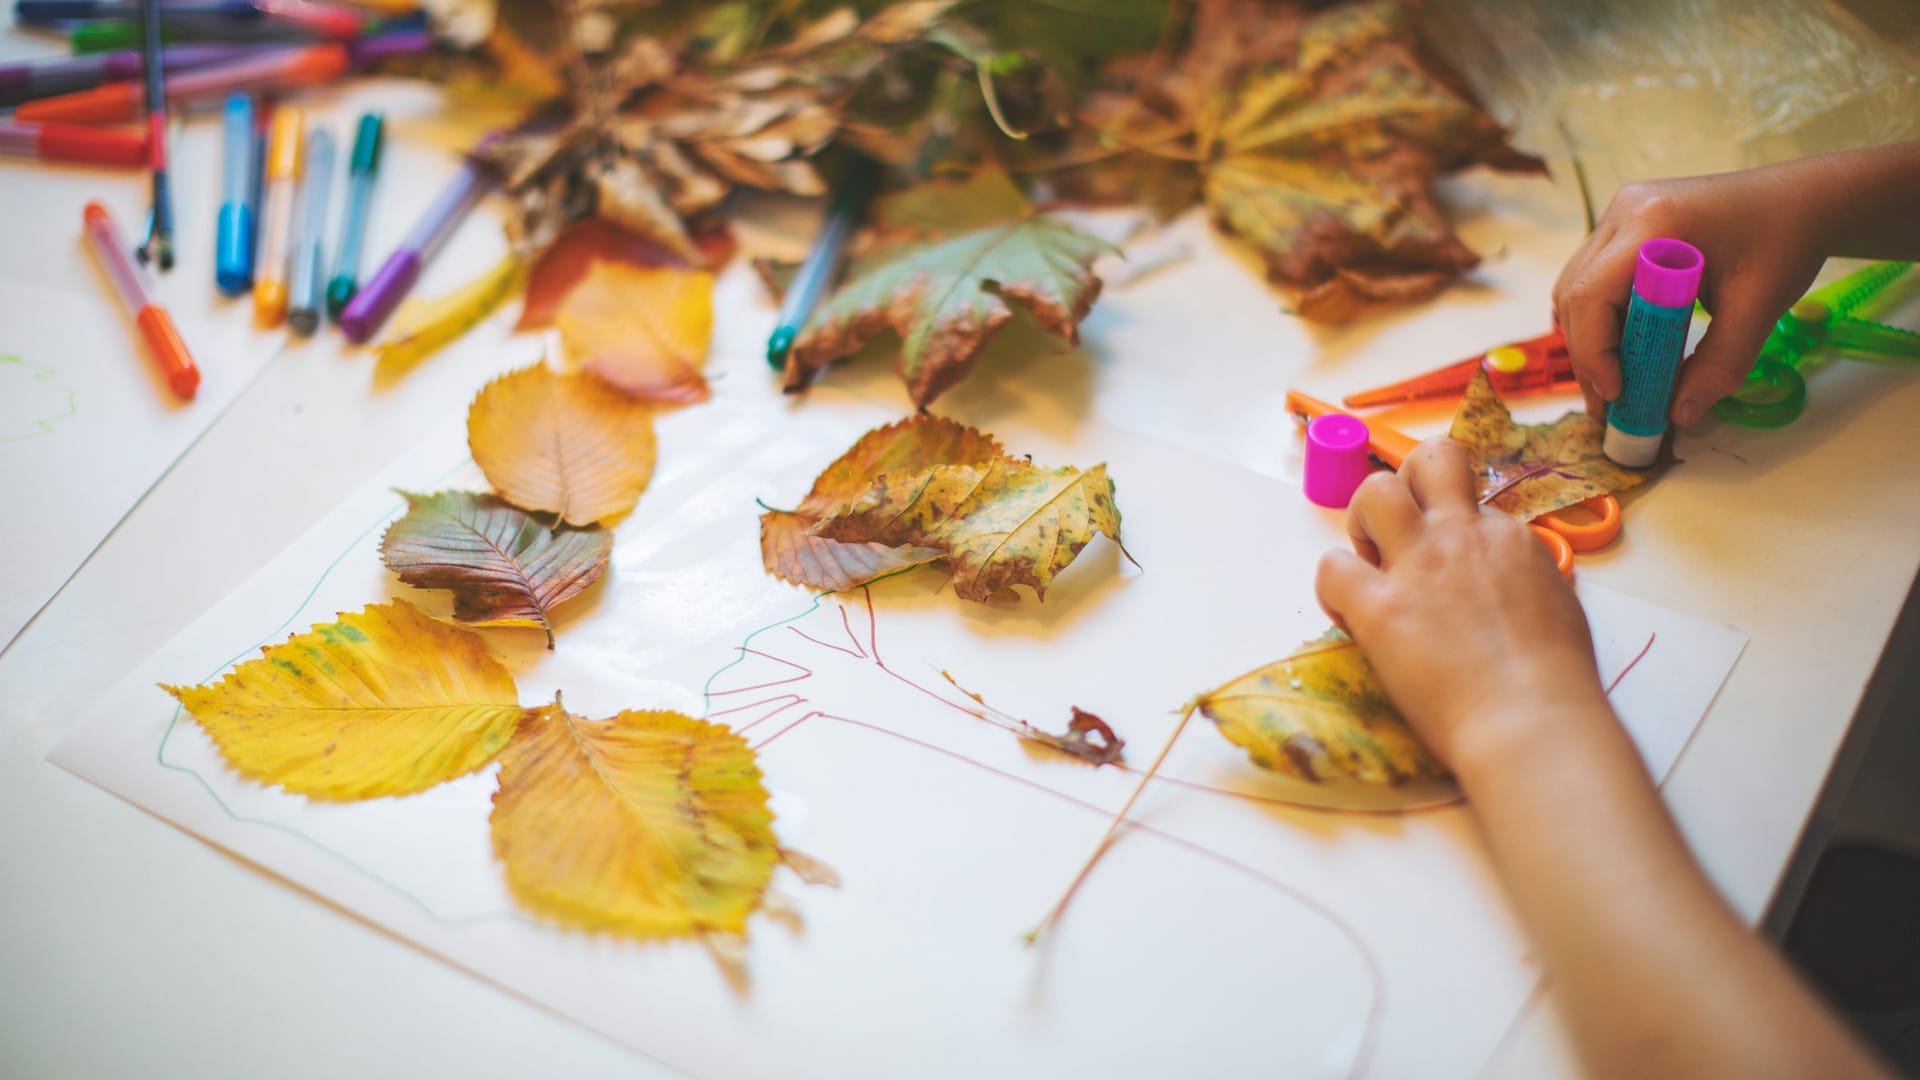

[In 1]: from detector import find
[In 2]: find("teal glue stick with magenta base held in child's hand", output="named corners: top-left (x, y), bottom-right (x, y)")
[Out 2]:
top-left (1599, 238), bottom-right (1707, 469)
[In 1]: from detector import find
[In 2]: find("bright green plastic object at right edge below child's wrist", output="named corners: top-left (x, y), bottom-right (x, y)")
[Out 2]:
top-left (1713, 263), bottom-right (1920, 429)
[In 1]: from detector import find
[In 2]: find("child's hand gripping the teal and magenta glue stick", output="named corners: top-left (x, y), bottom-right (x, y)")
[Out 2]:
top-left (1553, 163), bottom-right (1826, 427)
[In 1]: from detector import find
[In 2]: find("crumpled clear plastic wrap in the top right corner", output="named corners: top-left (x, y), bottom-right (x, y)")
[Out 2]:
top-left (1425, 0), bottom-right (1920, 209)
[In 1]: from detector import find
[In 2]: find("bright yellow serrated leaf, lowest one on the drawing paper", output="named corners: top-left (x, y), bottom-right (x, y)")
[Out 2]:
top-left (490, 701), bottom-right (781, 938)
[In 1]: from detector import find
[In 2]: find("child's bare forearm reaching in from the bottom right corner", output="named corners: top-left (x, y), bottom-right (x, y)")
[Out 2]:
top-left (1455, 701), bottom-right (1882, 1076)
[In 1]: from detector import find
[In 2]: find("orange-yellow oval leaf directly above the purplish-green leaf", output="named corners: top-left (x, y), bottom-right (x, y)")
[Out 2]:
top-left (467, 363), bottom-right (655, 525)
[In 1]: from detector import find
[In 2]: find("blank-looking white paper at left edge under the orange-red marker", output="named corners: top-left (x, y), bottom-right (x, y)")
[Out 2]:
top-left (0, 276), bottom-right (271, 648)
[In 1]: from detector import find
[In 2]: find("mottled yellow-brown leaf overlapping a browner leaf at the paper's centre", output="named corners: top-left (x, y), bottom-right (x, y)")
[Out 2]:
top-left (814, 449), bottom-right (1119, 601)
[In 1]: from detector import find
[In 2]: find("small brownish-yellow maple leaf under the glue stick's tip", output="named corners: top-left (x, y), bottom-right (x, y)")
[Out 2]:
top-left (1448, 369), bottom-right (1647, 521)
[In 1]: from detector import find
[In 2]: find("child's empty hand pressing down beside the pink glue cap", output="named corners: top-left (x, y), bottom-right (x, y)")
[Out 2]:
top-left (1315, 438), bottom-right (1611, 773)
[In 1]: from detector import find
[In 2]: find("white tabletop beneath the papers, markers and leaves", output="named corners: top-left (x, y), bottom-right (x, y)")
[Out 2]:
top-left (0, 37), bottom-right (1920, 1078)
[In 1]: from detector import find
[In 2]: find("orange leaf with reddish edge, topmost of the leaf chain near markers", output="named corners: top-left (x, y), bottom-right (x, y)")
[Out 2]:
top-left (553, 259), bottom-right (714, 405)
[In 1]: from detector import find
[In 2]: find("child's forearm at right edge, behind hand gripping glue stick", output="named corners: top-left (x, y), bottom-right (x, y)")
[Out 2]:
top-left (1780, 142), bottom-right (1920, 259)
